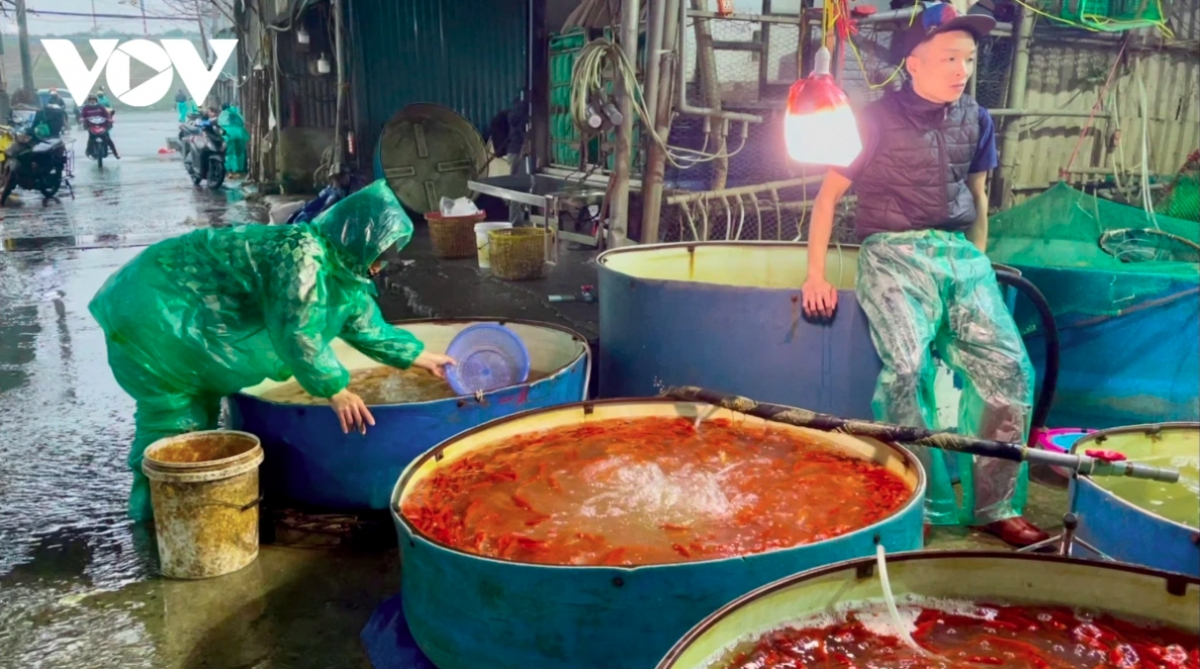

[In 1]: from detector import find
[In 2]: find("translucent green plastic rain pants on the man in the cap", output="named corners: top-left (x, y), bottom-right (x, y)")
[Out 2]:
top-left (857, 230), bottom-right (1034, 525)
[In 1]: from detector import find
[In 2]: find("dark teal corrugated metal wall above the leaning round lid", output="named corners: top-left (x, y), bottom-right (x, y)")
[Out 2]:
top-left (350, 0), bottom-right (528, 160)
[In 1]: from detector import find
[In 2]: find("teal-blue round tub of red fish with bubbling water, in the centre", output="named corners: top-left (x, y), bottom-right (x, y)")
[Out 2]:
top-left (392, 399), bottom-right (925, 669)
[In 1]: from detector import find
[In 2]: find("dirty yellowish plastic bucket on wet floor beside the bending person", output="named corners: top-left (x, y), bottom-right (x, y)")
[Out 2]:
top-left (142, 430), bottom-right (263, 579)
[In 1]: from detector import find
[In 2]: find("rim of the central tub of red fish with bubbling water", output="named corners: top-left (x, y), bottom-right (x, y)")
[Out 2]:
top-left (388, 397), bottom-right (928, 573)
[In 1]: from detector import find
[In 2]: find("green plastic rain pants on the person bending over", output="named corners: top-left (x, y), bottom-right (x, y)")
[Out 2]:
top-left (108, 342), bottom-right (221, 523)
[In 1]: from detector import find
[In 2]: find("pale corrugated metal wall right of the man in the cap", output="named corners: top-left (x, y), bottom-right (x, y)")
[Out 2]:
top-left (1009, 2), bottom-right (1200, 199)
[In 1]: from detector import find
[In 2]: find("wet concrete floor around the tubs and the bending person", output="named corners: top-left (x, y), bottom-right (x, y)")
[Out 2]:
top-left (0, 114), bottom-right (1066, 669)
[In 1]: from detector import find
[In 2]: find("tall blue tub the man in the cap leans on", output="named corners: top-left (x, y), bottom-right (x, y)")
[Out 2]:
top-left (599, 242), bottom-right (882, 418)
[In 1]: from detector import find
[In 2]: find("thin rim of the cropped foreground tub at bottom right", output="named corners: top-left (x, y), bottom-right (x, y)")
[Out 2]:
top-left (655, 550), bottom-right (1200, 669)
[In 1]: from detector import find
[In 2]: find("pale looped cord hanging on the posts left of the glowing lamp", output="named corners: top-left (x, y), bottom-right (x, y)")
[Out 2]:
top-left (570, 37), bottom-right (750, 169)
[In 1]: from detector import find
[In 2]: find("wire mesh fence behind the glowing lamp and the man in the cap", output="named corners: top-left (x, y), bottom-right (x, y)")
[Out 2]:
top-left (659, 5), bottom-right (1012, 242)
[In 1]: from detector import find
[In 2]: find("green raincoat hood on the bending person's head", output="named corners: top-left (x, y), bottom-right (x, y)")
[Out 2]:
top-left (312, 179), bottom-right (413, 271)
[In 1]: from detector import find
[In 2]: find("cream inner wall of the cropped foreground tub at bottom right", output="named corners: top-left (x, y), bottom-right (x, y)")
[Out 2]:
top-left (658, 552), bottom-right (1200, 669)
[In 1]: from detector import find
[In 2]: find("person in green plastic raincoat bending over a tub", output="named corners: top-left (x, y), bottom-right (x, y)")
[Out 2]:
top-left (89, 181), bottom-right (454, 520)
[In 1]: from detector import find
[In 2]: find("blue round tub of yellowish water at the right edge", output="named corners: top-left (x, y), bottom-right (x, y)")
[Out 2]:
top-left (1070, 423), bottom-right (1200, 578)
